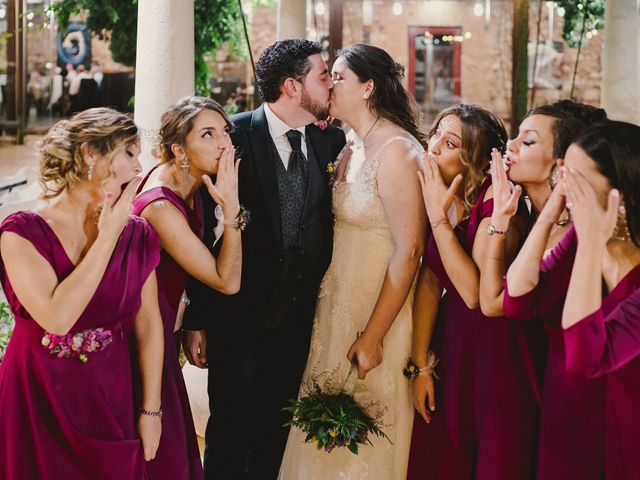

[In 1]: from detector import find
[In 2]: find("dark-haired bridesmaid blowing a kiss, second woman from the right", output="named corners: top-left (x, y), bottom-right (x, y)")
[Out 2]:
top-left (480, 100), bottom-right (606, 480)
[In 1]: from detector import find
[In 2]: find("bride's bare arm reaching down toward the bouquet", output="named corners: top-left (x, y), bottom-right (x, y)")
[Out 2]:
top-left (347, 142), bottom-right (426, 378)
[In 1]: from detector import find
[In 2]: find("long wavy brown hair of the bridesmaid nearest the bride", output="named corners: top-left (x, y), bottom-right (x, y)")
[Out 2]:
top-left (429, 103), bottom-right (508, 217)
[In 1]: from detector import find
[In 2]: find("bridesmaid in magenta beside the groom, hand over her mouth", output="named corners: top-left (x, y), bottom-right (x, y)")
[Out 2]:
top-left (133, 97), bottom-right (241, 480)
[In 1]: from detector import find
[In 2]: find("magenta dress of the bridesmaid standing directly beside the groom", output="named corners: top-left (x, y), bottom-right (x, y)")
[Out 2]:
top-left (133, 183), bottom-right (204, 480)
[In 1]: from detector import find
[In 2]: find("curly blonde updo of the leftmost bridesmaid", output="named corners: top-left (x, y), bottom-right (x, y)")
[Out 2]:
top-left (38, 108), bottom-right (138, 199)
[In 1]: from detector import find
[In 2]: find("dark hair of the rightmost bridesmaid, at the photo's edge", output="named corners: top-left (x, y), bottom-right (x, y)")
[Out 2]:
top-left (574, 120), bottom-right (640, 247)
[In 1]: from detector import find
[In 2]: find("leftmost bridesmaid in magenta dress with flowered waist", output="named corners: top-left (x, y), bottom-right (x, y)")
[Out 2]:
top-left (0, 108), bottom-right (163, 480)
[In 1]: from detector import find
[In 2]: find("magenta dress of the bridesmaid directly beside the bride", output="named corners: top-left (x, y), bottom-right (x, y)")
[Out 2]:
top-left (407, 180), bottom-right (545, 480)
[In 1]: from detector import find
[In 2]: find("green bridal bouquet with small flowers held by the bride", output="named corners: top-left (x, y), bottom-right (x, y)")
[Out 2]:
top-left (283, 366), bottom-right (389, 455)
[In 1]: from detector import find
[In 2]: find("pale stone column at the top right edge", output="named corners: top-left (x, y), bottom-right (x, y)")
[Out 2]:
top-left (602, 0), bottom-right (640, 124)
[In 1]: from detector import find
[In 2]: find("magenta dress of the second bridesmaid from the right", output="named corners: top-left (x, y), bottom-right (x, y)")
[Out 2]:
top-left (504, 226), bottom-right (604, 480)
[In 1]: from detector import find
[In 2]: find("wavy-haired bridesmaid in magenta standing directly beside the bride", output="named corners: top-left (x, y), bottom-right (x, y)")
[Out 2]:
top-left (408, 105), bottom-right (542, 480)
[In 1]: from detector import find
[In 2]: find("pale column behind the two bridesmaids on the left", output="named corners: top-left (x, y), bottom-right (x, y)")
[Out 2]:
top-left (134, 0), bottom-right (195, 170)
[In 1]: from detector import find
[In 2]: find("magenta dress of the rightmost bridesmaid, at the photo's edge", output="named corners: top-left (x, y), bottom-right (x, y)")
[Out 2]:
top-left (562, 265), bottom-right (640, 480)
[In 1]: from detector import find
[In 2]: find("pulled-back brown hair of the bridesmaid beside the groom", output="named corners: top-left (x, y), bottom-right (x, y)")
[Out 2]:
top-left (153, 97), bottom-right (233, 164)
